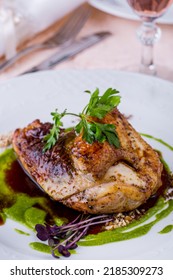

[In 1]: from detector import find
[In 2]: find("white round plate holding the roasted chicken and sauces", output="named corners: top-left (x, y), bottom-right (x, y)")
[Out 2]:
top-left (0, 70), bottom-right (173, 260)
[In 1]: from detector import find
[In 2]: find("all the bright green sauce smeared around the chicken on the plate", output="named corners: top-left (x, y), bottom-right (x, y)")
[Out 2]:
top-left (0, 134), bottom-right (173, 254)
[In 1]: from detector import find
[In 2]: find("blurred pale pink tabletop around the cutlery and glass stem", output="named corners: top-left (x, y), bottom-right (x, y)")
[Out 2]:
top-left (0, 3), bottom-right (173, 82)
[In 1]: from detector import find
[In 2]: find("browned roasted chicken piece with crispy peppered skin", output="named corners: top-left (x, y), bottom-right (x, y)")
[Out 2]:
top-left (13, 109), bottom-right (162, 214)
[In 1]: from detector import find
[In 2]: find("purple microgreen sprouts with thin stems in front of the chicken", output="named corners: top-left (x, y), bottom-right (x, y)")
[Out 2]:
top-left (35, 214), bottom-right (113, 258)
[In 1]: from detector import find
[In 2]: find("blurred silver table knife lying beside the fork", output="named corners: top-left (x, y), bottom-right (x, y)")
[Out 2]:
top-left (20, 31), bottom-right (111, 75)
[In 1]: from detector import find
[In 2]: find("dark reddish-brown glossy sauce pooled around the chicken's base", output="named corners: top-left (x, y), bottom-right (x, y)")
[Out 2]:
top-left (3, 158), bottom-right (172, 234)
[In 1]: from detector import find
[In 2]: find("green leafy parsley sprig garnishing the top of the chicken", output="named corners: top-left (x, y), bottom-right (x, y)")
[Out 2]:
top-left (43, 88), bottom-right (121, 152)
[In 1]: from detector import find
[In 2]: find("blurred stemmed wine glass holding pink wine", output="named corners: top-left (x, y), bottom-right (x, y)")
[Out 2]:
top-left (127, 0), bottom-right (173, 75)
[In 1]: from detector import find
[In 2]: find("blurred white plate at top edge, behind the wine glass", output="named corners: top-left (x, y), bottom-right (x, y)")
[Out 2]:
top-left (89, 0), bottom-right (173, 24)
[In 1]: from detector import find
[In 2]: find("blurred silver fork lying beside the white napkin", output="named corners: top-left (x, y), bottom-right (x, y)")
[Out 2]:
top-left (0, 5), bottom-right (91, 73)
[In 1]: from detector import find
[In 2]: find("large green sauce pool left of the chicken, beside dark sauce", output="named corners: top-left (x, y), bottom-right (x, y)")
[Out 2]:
top-left (0, 149), bottom-right (64, 230)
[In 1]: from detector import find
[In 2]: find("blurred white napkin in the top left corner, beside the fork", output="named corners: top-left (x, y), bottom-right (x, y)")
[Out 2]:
top-left (0, 0), bottom-right (86, 58)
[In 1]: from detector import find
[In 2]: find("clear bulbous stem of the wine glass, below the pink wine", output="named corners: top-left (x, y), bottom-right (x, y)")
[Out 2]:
top-left (137, 20), bottom-right (161, 75)
